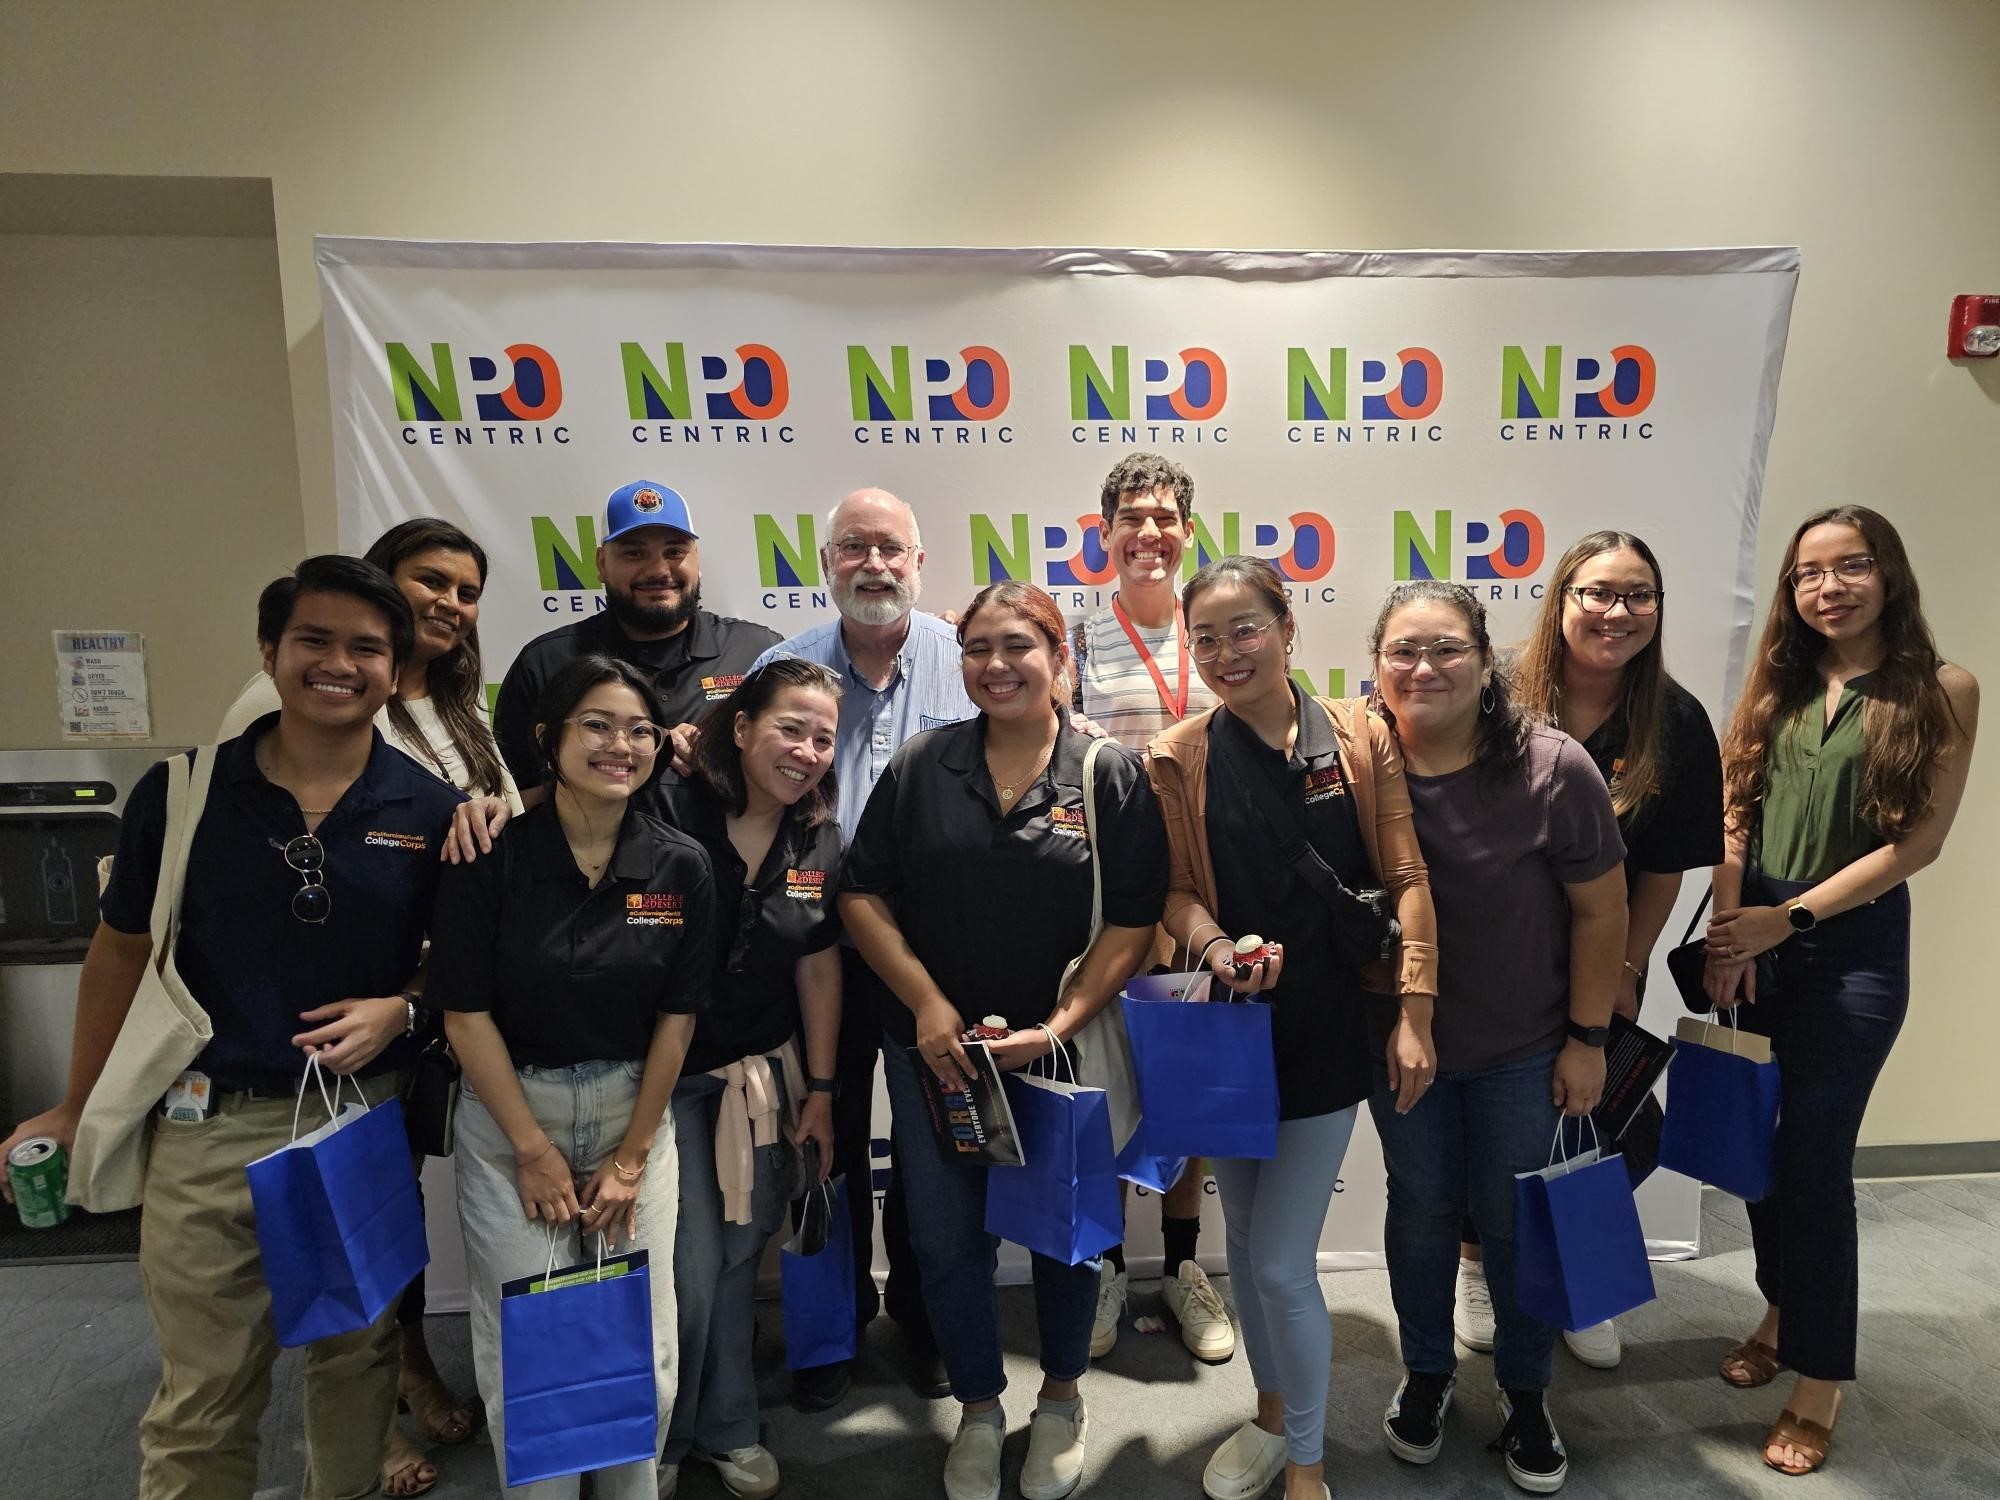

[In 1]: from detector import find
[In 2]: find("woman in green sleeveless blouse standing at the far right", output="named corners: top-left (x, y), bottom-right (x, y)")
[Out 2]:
top-left (1706, 506), bottom-right (1980, 1474)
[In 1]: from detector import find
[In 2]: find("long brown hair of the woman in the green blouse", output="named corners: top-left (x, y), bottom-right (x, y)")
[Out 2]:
top-left (1722, 506), bottom-right (1960, 842)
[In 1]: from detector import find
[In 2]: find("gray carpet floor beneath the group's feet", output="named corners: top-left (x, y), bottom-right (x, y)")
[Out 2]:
top-left (0, 1178), bottom-right (2000, 1500)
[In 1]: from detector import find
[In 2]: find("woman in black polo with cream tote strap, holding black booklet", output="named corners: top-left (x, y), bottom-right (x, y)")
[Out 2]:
top-left (840, 582), bottom-right (1166, 1500)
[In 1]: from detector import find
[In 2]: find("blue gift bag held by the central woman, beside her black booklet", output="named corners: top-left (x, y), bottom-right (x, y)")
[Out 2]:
top-left (986, 1072), bottom-right (1124, 1266)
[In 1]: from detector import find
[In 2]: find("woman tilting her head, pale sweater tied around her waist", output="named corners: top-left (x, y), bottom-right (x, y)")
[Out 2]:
top-left (660, 656), bottom-right (842, 1500)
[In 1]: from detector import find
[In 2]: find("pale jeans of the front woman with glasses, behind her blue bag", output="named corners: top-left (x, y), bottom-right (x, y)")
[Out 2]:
top-left (454, 1062), bottom-right (680, 1500)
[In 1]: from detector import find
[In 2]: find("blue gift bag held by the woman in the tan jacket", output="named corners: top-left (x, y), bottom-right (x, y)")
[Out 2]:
top-left (1124, 974), bottom-right (1278, 1160)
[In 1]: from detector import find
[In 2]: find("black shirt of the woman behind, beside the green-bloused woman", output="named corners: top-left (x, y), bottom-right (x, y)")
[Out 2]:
top-left (1584, 678), bottom-right (1722, 892)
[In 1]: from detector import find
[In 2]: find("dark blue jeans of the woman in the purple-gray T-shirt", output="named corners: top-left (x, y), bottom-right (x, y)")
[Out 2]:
top-left (1368, 1052), bottom-right (1558, 1390)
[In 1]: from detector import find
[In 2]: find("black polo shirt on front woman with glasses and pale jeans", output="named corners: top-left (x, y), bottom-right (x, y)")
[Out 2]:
top-left (428, 802), bottom-right (716, 1068)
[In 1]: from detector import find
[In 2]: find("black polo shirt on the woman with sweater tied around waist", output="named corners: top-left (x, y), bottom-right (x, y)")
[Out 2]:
top-left (664, 780), bottom-right (840, 1074)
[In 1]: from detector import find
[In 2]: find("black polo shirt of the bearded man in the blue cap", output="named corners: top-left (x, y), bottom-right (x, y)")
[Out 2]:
top-left (494, 610), bottom-right (782, 812)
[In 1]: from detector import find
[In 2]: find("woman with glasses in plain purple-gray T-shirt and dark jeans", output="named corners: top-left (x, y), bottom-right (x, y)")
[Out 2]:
top-left (1370, 580), bottom-right (1626, 1494)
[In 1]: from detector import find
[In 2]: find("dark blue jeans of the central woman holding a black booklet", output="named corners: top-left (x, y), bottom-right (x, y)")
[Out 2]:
top-left (882, 1036), bottom-right (1100, 1402)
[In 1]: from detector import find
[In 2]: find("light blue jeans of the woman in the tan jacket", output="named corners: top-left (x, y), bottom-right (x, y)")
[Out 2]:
top-left (1208, 1104), bottom-right (1360, 1464)
